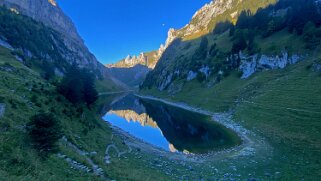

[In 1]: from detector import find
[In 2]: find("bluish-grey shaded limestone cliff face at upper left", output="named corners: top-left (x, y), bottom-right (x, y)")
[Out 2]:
top-left (0, 0), bottom-right (105, 73)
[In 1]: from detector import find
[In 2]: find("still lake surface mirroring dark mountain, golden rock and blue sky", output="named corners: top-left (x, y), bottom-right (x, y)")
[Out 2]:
top-left (103, 94), bottom-right (241, 153)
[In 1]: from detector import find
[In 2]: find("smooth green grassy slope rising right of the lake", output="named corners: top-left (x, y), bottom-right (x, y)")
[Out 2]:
top-left (141, 31), bottom-right (321, 179)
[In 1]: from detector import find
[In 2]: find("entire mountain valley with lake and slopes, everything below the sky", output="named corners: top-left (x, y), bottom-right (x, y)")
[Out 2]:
top-left (0, 0), bottom-right (321, 181)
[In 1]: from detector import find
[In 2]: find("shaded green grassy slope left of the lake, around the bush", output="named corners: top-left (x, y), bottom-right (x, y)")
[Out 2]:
top-left (0, 47), bottom-right (170, 180)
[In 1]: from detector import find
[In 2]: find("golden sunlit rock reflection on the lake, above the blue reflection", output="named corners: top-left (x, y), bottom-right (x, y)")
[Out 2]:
top-left (109, 110), bottom-right (158, 128)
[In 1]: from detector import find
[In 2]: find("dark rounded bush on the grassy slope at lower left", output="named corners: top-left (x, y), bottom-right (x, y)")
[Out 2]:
top-left (27, 113), bottom-right (62, 157)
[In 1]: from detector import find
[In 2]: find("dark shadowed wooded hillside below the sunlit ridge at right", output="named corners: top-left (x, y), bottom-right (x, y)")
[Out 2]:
top-left (141, 0), bottom-right (321, 90)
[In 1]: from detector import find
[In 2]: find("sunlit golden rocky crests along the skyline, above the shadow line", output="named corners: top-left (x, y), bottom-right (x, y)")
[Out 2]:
top-left (113, 0), bottom-right (277, 69)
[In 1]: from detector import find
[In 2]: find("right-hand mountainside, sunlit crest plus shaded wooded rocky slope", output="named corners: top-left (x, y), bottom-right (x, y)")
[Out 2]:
top-left (142, 0), bottom-right (320, 95)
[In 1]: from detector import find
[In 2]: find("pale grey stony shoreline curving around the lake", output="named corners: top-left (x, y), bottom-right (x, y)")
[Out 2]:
top-left (103, 94), bottom-right (268, 163)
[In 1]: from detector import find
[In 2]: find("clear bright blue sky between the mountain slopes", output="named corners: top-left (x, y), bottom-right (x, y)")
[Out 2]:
top-left (57, 0), bottom-right (210, 64)
